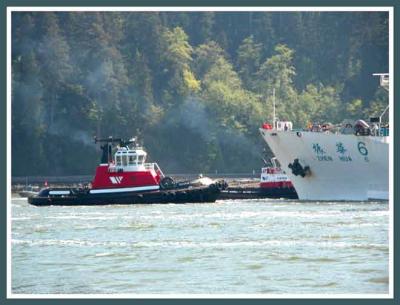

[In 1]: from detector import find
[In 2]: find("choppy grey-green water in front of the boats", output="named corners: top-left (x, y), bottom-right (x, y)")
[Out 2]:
top-left (11, 198), bottom-right (389, 294)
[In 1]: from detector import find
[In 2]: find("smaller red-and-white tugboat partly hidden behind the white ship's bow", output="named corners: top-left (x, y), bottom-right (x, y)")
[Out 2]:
top-left (220, 158), bottom-right (298, 199)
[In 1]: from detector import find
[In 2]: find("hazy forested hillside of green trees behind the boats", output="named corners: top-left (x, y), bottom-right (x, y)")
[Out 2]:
top-left (12, 12), bottom-right (388, 176)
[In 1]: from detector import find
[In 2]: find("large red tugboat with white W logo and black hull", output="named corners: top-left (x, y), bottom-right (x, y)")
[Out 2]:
top-left (28, 137), bottom-right (227, 206)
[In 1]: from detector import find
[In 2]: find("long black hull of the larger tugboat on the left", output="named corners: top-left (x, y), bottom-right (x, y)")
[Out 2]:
top-left (28, 186), bottom-right (221, 206)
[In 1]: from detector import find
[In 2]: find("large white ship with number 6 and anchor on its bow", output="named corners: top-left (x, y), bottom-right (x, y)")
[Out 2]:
top-left (260, 74), bottom-right (389, 201)
